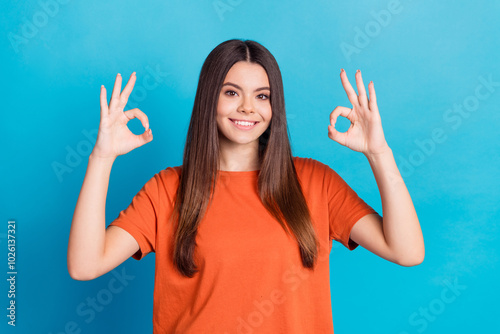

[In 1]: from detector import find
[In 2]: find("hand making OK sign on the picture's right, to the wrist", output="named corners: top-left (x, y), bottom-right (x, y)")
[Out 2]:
top-left (328, 69), bottom-right (389, 155)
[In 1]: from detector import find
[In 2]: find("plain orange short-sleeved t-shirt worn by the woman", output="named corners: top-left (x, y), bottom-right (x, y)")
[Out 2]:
top-left (110, 157), bottom-right (376, 334)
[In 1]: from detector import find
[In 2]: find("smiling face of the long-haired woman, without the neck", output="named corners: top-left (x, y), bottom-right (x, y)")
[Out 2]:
top-left (217, 61), bottom-right (272, 147)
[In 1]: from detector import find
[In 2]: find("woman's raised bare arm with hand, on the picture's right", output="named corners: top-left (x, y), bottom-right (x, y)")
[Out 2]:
top-left (329, 70), bottom-right (425, 266)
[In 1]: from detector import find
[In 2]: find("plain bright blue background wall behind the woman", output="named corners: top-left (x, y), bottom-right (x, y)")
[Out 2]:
top-left (0, 0), bottom-right (500, 334)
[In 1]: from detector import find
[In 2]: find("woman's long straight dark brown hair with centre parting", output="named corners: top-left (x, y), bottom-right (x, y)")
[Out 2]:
top-left (172, 39), bottom-right (318, 277)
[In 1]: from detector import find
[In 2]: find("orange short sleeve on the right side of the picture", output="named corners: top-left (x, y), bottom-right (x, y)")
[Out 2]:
top-left (325, 165), bottom-right (377, 251)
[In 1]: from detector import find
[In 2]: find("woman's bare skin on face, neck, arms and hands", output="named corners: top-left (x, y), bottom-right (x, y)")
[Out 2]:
top-left (67, 62), bottom-right (425, 280)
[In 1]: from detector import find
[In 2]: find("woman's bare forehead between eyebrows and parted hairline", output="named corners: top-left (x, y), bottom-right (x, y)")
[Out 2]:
top-left (224, 61), bottom-right (269, 87)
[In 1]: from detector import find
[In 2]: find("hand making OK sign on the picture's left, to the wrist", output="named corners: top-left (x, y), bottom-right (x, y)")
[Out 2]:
top-left (92, 72), bottom-right (153, 159)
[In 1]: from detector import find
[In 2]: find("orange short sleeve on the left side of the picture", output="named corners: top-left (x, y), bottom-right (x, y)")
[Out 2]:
top-left (109, 174), bottom-right (159, 260)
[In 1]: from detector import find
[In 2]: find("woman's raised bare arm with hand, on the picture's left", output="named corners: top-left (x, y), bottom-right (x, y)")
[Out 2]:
top-left (67, 72), bottom-right (153, 280)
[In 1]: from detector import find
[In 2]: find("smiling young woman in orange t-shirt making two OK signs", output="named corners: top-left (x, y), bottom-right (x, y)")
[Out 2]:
top-left (68, 40), bottom-right (424, 334)
